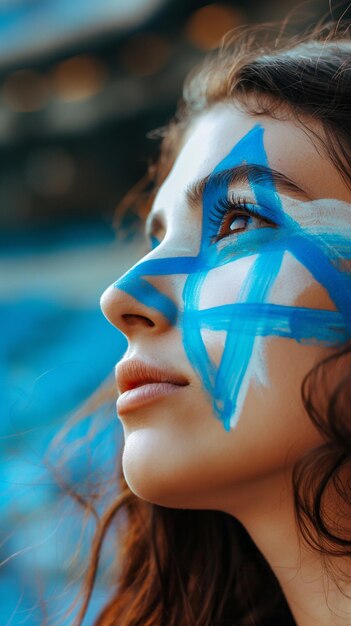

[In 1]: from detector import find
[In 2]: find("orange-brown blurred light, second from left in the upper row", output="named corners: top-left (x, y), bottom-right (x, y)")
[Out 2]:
top-left (53, 54), bottom-right (107, 102)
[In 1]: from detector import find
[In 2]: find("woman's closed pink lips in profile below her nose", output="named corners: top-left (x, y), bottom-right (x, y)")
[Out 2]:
top-left (116, 359), bottom-right (189, 415)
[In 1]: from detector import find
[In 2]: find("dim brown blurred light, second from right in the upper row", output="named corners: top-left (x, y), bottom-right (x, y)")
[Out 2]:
top-left (119, 33), bottom-right (170, 76)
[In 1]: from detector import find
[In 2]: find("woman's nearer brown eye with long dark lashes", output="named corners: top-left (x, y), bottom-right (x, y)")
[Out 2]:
top-left (209, 198), bottom-right (274, 242)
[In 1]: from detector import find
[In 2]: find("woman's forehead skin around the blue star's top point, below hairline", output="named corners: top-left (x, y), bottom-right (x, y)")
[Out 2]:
top-left (154, 103), bottom-right (351, 210)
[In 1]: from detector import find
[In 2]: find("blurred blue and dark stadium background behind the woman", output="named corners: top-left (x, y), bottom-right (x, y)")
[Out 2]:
top-left (0, 0), bottom-right (348, 626)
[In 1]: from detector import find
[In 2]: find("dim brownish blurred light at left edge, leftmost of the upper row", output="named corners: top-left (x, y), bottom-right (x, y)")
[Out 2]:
top-left (3, 70), bottom-right (50, 113)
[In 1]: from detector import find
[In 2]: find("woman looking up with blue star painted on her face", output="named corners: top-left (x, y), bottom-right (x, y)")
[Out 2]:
top-left (73, 19), bottom-right (351, 626)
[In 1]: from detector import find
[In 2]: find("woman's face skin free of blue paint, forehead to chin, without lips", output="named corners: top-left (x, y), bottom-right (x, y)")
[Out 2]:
top-left (102, 105), bottom-right (351, 519)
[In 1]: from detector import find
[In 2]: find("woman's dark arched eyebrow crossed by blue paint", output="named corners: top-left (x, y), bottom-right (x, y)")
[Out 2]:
top-left (185, 163), bottom-right (311, 207)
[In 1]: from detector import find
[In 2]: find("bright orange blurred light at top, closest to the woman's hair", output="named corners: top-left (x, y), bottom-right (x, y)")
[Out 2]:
top-left (184, 4), bottom-right (245, 51)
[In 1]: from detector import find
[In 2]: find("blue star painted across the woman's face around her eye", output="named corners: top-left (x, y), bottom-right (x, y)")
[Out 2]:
top-left (115, 125), bottom-right (351, 430)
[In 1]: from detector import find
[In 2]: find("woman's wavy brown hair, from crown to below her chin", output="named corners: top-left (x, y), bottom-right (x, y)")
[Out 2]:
top-left (55, 14), bottom-right (351, 626)
